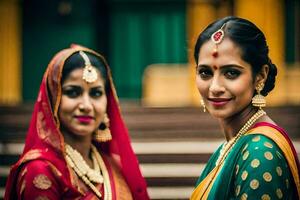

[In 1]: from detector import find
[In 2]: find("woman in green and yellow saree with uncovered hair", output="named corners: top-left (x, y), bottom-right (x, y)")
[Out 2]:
top-left (190, 17), bottom-right (300, 200)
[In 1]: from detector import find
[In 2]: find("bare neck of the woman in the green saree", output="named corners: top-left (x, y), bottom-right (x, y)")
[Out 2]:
top-left (219, 105), bottom-right (257, 141)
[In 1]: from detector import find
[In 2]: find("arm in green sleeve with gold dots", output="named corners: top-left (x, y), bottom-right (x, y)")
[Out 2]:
top-left (232, 136), bottom-right (292, 199)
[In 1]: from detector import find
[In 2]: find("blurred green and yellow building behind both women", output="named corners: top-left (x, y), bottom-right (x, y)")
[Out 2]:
top-left (0, 0), bottom-right (300, 106)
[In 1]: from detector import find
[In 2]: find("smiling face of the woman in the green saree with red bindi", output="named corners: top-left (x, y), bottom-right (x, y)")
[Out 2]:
top-left (196, 38), bottom-right (255, 119)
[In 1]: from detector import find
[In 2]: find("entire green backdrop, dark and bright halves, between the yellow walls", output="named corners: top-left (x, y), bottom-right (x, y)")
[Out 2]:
top-left (23, 0), bottom-right (187, 101)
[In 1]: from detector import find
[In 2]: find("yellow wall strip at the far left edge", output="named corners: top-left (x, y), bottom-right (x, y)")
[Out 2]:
top-left (0, 0), bottom-right (21, 104)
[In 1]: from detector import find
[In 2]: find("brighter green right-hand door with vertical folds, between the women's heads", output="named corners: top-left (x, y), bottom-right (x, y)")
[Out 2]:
top-left (108, 0), bottom-right (187, 99)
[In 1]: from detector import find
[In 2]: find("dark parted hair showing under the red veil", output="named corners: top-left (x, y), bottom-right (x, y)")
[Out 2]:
top-left (61, 52), bottom-right (108, 91)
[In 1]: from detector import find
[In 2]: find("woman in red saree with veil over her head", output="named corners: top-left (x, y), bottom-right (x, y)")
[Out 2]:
top-left (5, 45), bottom-right (149, 200)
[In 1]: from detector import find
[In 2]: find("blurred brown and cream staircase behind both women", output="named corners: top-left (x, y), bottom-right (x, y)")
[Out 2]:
top-left (0, 102), bottom-right (300, 200)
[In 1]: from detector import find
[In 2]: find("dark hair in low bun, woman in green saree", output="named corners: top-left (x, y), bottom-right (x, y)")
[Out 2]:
top-left (194, 16), bottom-right (277, 96)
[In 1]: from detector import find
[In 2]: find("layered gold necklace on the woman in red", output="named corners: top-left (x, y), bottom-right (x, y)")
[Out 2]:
top-left (65, 144), bottom-right (112, 200)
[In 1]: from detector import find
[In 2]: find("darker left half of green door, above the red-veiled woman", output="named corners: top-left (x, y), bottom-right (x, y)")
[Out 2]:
top-left (22, 0), bottom-right (102, 102)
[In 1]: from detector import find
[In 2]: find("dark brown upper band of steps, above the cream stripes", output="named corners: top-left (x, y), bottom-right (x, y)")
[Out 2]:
top-left (0, 103), bottom-right (300, 142)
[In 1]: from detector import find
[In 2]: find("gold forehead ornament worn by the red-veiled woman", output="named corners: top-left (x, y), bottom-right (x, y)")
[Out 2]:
top-left (79, 51), bottom-right (98, 83)
